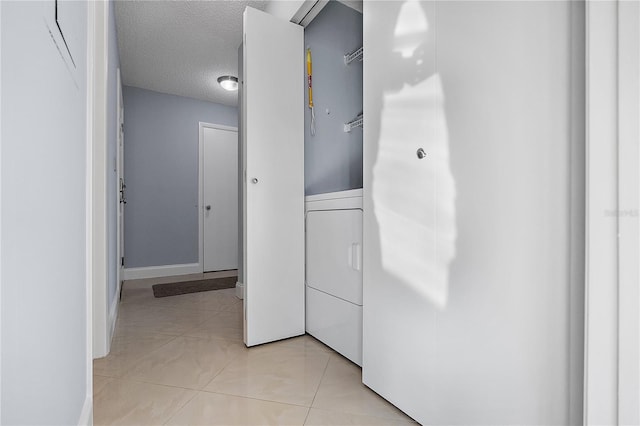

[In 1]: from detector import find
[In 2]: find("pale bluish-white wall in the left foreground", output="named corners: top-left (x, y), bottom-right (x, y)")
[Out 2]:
top-left (0, 1), bottom-right (91, 425)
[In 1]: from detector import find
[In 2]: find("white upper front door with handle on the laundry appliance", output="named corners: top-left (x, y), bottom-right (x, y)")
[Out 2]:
top-left (306, 209), bottom-right (362, 305)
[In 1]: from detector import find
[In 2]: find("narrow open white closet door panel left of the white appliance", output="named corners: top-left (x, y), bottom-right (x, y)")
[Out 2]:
top-left (242, 8), bottom-right (305, 346)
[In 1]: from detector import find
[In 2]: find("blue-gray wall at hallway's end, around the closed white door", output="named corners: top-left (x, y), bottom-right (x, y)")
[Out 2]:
top-left (124, 86), bottom-right (238, 268)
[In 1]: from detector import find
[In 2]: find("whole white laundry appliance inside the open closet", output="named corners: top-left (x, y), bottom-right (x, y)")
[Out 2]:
top-left (305, 189), bottom-right (362, 365)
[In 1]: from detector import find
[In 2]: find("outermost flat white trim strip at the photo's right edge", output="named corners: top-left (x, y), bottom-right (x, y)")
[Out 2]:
top-left (617, 1), bottom-right (640, 424)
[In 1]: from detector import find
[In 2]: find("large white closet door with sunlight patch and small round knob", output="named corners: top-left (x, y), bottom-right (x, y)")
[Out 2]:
top-left (363, 1), bottom-right (584, 425)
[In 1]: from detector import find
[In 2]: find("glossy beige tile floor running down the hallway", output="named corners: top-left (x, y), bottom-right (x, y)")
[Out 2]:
top-left (94, 273), bottom-right (413, 425)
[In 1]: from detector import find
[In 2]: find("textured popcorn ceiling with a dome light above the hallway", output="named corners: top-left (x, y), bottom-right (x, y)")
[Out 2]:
top-left (115, 0), bottom-right (266, 106)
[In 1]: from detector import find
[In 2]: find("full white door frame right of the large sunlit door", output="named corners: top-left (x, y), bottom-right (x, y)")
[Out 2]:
top-left (583, 0), bottom-right (640, 425)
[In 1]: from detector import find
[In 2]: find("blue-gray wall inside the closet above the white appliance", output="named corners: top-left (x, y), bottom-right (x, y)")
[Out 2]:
top-left (304, 1), bottom-right (366, 195)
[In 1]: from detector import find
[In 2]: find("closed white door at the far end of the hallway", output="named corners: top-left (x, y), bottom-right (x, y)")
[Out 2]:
top-left (202, 125), bottom-right (238, 272)
